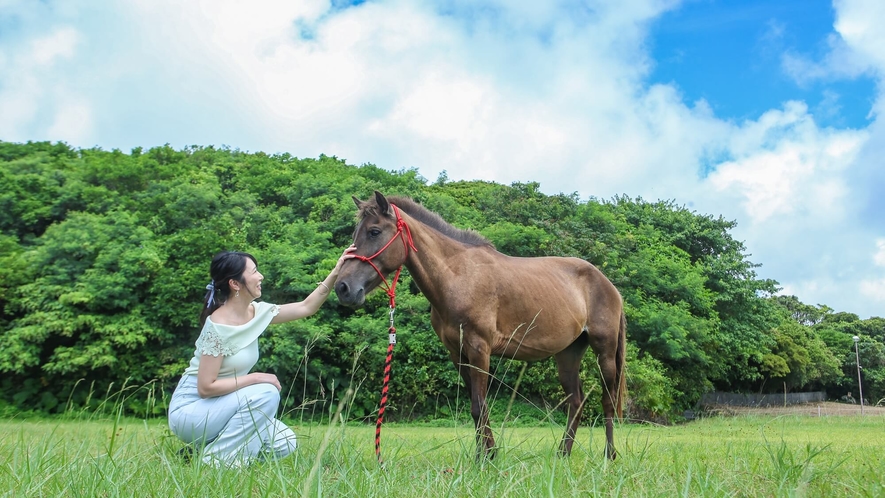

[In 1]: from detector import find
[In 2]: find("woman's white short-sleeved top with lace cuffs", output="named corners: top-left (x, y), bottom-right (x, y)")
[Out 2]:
top-left (184, 302), bottom-right (280, 379)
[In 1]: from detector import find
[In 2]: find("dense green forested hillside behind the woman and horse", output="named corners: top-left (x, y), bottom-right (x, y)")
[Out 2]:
top-left (0, 142), bottom-right (885, 420)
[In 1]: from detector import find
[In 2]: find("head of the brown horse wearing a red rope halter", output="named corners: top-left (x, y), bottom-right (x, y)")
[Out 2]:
top-left (335, 191), bottom-right (411, 307)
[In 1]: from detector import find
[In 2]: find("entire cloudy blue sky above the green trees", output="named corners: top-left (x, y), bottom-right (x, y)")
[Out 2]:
top-left (0, 0), bottom-right (885, 317)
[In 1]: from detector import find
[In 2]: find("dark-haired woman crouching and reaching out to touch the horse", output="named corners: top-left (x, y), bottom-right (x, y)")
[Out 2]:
top-left (169, 246), bottom-right (356, 466)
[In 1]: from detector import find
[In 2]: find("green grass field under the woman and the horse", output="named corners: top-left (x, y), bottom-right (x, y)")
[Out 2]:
top-left (0, 416), bottom-right (885, 498)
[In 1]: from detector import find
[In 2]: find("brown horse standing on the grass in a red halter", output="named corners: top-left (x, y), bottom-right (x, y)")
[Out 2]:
top-left (335, 192), bottom-right (626, 459)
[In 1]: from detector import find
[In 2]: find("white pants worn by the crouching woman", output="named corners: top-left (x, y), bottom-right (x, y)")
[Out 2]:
top-left (169, 375), bottom-right (295, 466)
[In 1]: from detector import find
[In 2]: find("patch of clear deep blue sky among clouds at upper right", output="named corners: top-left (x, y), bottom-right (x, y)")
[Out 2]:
top-left (649, 0), bottom-right (876, 128)
